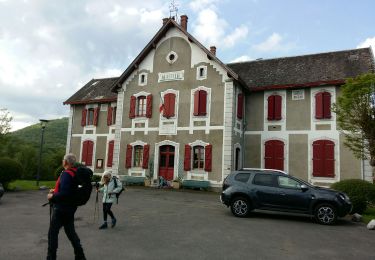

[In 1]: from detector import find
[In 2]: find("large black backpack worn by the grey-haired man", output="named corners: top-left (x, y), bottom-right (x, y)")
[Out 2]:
top-left (67, 166), bottom-right (93, 206)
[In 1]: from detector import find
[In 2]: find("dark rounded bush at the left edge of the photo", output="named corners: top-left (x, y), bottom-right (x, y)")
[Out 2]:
top-left (0, 157), bottom-right (23, 189)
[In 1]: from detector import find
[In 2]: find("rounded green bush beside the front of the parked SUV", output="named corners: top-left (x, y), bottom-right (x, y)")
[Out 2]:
top-left (331, 179), bottom-right (375, 214)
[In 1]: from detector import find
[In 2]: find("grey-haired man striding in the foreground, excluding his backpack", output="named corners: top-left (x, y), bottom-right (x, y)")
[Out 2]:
top-left (47, 153), bottom-right (86, 260)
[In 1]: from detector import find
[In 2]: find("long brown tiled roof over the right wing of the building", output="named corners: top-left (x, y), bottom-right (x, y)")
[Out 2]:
top-left (227, 48), bottom-right (375, 91)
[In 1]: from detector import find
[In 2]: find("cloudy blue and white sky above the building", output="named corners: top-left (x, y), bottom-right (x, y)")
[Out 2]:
top-left (0, 0), bottom-right (375, 130)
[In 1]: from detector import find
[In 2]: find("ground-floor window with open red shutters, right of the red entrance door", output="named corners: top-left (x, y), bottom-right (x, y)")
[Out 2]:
top-left (184, 144), bottom-right (212, 172)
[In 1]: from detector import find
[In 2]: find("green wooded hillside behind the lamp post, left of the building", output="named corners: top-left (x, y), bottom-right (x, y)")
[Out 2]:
top-left (10, 117), bottom-right (68, 151)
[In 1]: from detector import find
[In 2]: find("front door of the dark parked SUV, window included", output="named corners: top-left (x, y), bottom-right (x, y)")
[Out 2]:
top-left (276, 175), bottom-right (311, 212)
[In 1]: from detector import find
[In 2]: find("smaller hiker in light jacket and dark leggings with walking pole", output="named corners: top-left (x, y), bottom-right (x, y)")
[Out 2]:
top-left (96, 171), bottom-right (122, 229)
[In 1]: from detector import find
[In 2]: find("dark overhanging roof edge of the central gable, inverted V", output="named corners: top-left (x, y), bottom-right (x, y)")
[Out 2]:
top-left (112, 18), bottom-right (246, 92)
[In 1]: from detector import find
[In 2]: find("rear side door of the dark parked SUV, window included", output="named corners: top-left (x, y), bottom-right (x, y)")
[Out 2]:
top-left (252, 173), bottom-right (279, 208)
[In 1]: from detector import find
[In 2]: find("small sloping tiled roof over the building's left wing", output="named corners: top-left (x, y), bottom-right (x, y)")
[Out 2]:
top-left (64, 77), bottom-right (118, 105)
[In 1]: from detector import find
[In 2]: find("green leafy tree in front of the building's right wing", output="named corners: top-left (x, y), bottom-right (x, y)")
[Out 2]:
top-left (333, 73), bottom-right (375, 177)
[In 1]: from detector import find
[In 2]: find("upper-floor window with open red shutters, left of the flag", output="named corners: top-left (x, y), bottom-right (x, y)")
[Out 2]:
top-left (129, 94), bottom-right (152, 118)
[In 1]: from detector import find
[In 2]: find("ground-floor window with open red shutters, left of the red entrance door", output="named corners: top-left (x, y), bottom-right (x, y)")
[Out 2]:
top-left (125, 144), bottom-right (150, 169)
